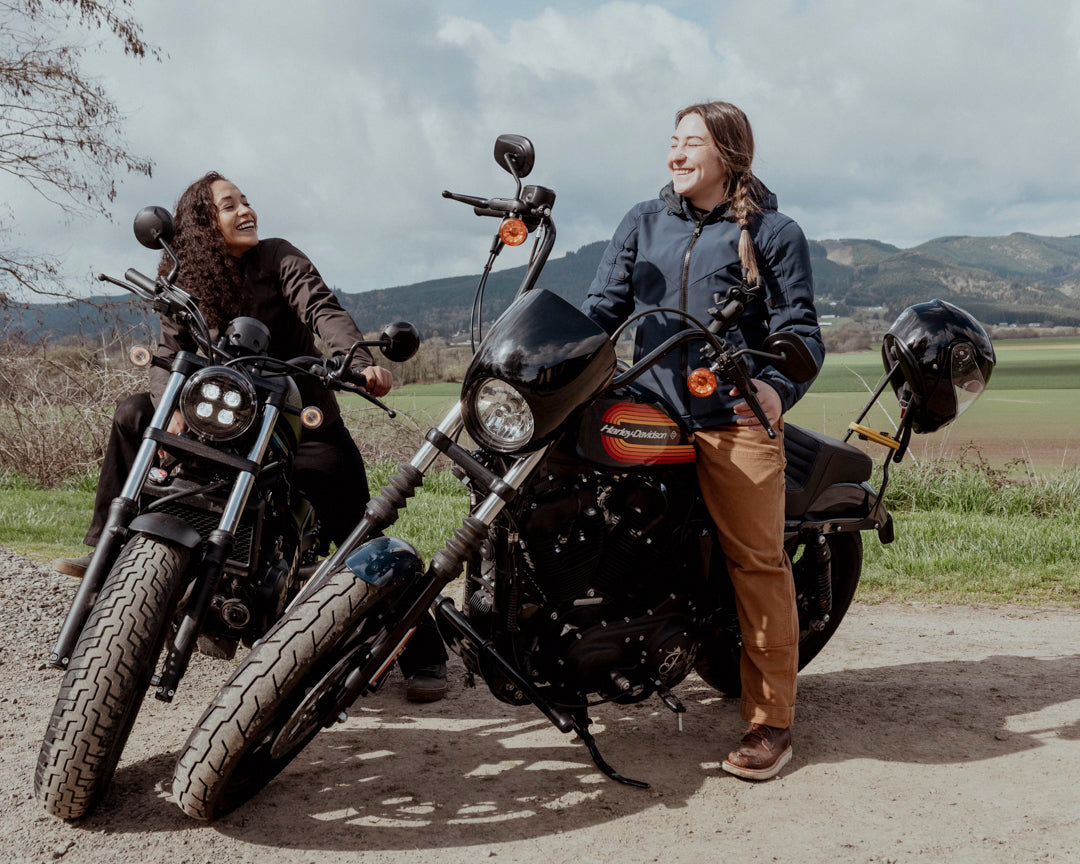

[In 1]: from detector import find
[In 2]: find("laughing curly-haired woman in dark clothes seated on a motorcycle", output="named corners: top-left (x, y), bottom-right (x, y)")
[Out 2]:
top-left (53, 172), bottom-right (447, 701)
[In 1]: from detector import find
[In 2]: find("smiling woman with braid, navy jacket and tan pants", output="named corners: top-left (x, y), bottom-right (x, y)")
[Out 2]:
top-left (583, 102), bottom-right (825, 780)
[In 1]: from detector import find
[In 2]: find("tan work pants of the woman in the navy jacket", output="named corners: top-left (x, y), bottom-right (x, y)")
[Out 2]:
top-left (694, 423), bottom-right (799, 728)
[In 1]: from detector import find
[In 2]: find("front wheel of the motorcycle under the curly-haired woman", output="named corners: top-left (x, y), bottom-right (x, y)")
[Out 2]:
top-left (33, 535), bottom-right (189, 820)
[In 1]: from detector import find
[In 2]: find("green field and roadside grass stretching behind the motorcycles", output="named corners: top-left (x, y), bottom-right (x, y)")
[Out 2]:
top-left (0, 340), bottom-right (1080, 606)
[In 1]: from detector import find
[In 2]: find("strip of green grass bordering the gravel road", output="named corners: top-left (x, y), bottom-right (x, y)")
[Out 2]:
top-left (0, 463), bottom-right (1080, 607)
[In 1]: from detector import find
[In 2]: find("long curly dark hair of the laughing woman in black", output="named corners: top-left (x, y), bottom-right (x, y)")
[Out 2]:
top-left (158, 171), bottom-right (248, 329)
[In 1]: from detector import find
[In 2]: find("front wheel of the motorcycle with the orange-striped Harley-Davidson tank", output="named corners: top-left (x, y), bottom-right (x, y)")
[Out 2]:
top-left (173, 569), bottom-right (397, 821)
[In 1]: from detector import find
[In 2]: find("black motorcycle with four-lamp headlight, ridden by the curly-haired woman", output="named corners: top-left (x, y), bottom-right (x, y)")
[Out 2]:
top-left (33, 207), bottom-right (419, 819)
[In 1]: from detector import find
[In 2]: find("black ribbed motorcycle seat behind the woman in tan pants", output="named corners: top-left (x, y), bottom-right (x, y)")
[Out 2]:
top-left (784, 423), bottom-right (874, 517)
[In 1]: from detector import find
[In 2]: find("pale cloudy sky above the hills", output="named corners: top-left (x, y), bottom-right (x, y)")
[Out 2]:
top-left (6, 0), bottom-right (1080, 293)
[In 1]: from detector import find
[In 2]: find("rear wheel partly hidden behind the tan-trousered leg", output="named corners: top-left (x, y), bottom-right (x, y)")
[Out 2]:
top-left (694, 531), bottom-right (863, 696)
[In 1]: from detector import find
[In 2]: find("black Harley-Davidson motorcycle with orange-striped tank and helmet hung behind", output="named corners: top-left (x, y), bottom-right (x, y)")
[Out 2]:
top-left (173, 135), bottom-right (993, 820)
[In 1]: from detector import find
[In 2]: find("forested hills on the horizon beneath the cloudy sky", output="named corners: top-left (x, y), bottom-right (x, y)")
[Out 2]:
top-left (8, 233), bottom-right (1080, 340)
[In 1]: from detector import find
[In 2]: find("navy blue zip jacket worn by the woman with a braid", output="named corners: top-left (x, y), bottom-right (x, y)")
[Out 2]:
top-left (582, 184), bottom-right (825, 429)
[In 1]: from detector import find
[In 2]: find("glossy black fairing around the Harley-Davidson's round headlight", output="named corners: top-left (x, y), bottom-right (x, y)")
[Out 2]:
top-left (462, 288), bottom-right (616, 450)
